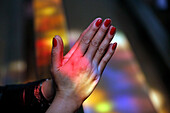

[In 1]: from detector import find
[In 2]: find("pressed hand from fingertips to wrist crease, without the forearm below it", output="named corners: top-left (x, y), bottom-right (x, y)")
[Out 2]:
top-left (51, 19), bottom-right (116, 104)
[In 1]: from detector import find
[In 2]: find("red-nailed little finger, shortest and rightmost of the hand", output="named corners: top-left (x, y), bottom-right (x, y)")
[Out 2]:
top-left (98, 42), bottom-right (117, 75)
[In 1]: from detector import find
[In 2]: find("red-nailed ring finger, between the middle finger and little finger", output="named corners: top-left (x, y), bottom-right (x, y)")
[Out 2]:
top-left (93, 26), bottom-right (116, 65)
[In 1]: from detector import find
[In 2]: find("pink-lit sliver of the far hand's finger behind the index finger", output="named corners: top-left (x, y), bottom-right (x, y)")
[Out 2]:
top-left (64, 20), bottom-right (95, 59)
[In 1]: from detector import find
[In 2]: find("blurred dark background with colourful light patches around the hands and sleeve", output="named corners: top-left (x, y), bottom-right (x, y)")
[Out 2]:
top-left (0, 0), bottom-right (170, 113)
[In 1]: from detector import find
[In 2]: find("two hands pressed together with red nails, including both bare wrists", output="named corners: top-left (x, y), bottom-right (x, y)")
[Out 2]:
top-left (42, 18), bottom-right (117, 113)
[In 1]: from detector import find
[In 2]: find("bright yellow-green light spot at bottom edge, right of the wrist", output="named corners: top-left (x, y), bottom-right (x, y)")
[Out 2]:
top-left (95, 102), bottom-right (113, 113)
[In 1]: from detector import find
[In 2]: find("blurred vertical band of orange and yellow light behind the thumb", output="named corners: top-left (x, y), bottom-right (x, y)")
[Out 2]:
top-left (33, 0), bottom-right (68, 78)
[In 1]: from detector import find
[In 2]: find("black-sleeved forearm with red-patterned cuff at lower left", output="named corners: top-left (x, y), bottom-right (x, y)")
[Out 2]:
top-left (0, 80), bottom-right (49, 113)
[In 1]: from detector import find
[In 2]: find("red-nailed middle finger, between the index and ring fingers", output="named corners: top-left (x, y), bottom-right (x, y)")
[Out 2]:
top-left (85, 19), bottom-right (111, 61)
